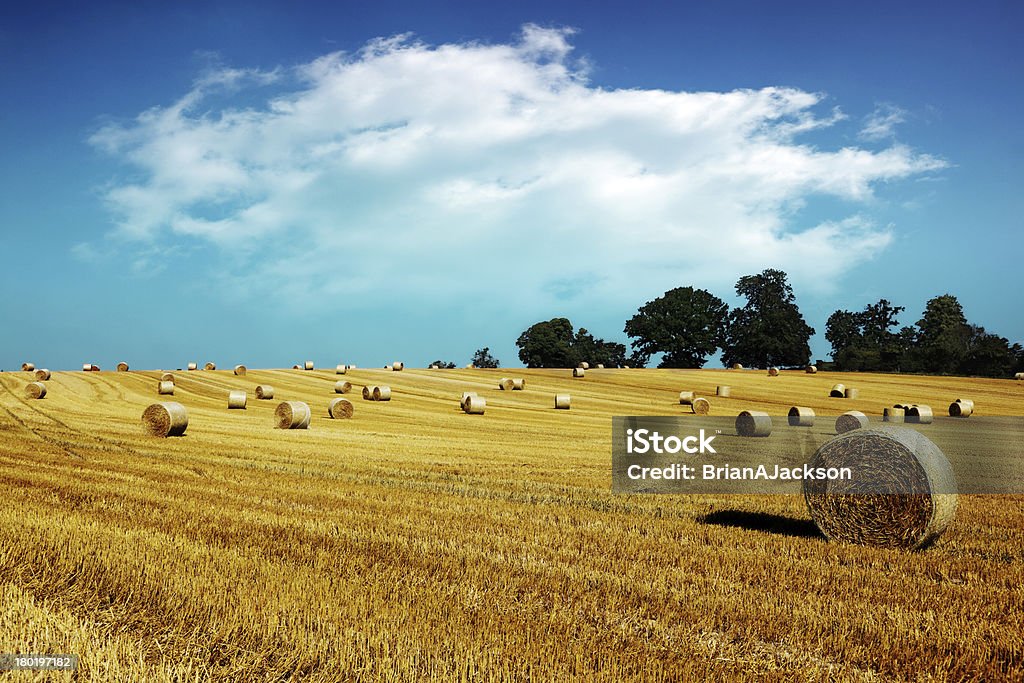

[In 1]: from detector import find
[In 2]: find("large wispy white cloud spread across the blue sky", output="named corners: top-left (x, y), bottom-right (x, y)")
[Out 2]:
top-left (88, 25), bottom-right (944, 317)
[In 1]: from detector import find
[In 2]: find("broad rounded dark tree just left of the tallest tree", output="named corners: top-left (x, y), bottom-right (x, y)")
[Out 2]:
top-left (625, 287), bottom-right (729, 368)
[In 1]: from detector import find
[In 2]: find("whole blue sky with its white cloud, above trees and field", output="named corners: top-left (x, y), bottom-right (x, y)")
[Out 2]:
top-left (0, 2), bottom-right (1024, 369)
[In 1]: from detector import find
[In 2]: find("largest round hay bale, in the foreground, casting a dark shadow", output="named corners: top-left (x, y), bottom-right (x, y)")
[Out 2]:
top-left (804, 427), bottom-right (956, 550)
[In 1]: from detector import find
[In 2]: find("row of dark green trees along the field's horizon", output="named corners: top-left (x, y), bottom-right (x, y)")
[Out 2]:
top-left (507, 268), bottom-right (1024, 377)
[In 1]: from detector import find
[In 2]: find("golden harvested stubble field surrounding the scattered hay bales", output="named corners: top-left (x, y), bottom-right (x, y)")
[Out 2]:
top-left (0, 369), bottom-right (1024, 681)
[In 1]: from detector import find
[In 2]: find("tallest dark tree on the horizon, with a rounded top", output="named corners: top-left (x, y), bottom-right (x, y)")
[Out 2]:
top-left (722, 268), bottom-right (814, 368)
